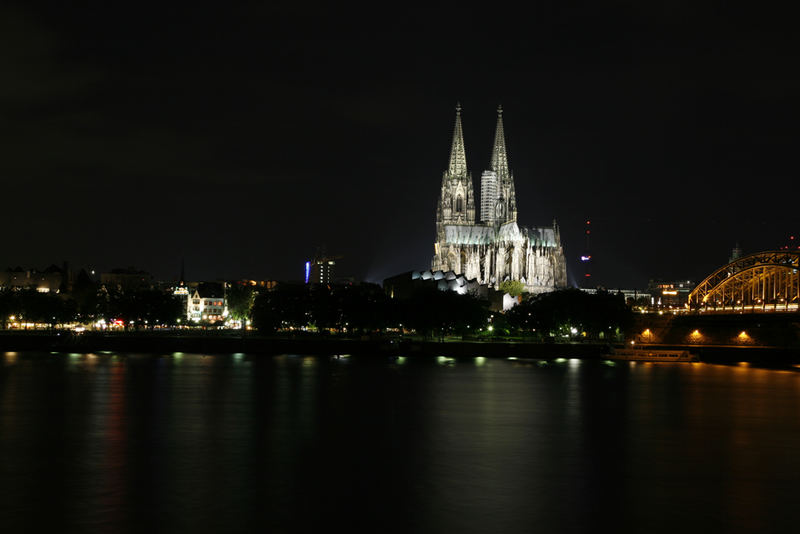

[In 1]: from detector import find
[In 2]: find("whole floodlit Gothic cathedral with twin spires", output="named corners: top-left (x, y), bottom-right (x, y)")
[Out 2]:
top-left (431, 106), bottom-right (567, 293)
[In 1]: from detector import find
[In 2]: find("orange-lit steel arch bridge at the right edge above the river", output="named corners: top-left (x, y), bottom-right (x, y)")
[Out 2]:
top-left (688, 250), bottom-right (800, 312)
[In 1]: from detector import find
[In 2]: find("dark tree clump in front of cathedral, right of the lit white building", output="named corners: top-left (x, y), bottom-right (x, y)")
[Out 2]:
top-left (252, 284), bottom-right (633, 340)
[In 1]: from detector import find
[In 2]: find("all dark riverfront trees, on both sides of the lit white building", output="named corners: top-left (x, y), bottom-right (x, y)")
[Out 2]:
top-left (0, 277), bottom-right (633, 340)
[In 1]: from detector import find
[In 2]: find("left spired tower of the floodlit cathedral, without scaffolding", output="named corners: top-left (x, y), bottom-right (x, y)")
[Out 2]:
top-left (436, 104), bottom-right (475, 241)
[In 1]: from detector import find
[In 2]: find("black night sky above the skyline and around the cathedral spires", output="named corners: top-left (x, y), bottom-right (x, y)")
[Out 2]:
top-left (0, 2), bottom-right (800, 287)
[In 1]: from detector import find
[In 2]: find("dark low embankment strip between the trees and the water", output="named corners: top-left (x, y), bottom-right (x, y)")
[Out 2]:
top-left (0, 332), bottom-right (800, 365)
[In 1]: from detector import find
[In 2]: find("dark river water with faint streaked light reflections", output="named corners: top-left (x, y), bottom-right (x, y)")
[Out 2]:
top-left (0, 353), bottom-right (800, 532)
